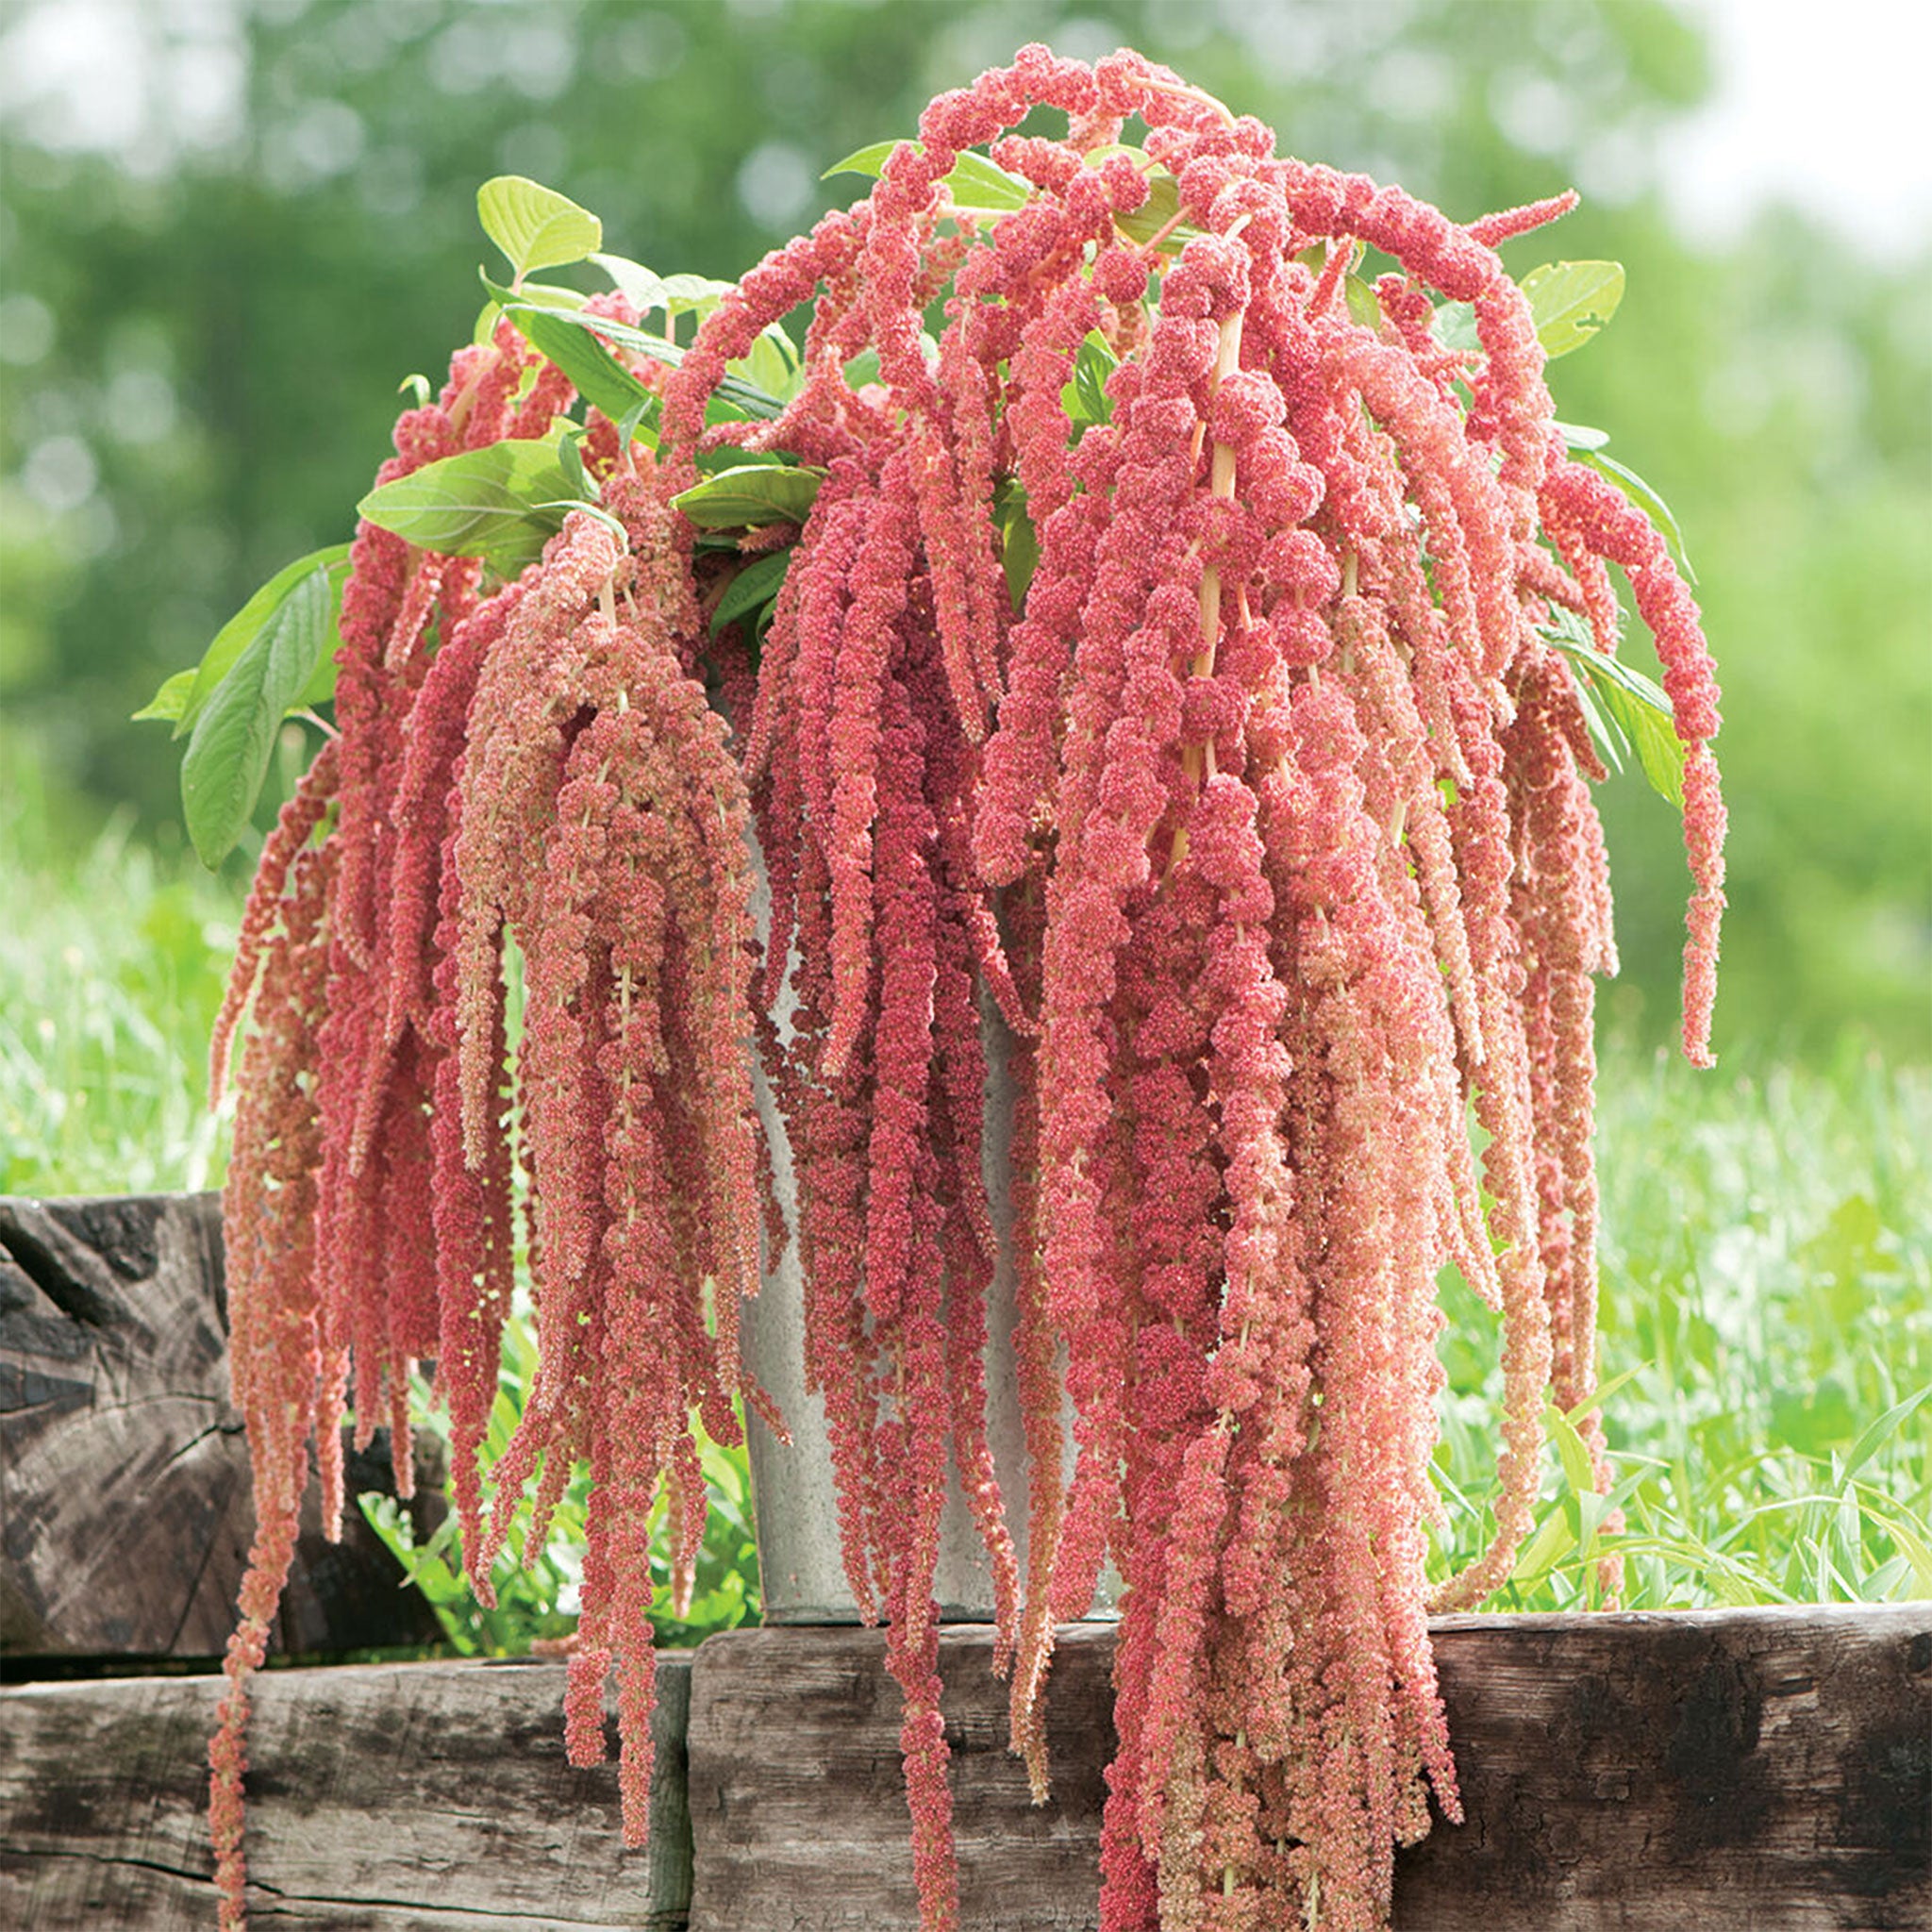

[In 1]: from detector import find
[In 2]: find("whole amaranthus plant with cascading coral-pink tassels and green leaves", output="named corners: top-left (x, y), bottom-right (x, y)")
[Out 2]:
top-left (150, 46), bottom-right (1724, 1932)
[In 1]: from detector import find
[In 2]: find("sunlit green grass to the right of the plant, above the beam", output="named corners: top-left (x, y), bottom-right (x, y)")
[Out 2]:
top-left (1438, 1051), bottom-right (1932, 1609)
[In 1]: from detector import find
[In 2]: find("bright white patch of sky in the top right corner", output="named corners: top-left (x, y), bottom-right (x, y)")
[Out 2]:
top-left (1665, 0), bottom-right (1932, 255)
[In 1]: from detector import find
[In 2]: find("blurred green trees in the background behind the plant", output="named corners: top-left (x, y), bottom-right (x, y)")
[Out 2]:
top-left (0, 0), bottom-right (1932, 1060)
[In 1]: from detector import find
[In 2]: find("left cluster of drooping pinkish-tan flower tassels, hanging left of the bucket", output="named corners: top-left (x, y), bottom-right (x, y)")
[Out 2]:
top-left (202, 323), bottom-right (759, 1923)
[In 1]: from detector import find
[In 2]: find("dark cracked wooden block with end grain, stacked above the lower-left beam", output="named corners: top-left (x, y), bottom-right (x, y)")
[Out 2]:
top-left (0, 1194), bottom-right (444, 1657)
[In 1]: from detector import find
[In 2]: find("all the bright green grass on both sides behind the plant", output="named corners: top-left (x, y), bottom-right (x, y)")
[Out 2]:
top-left (0, 743), bottom-right (1932, 1650)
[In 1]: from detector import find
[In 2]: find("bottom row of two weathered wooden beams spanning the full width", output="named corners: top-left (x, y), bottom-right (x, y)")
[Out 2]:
top-left (0, 1606), bottom-right (1932, 1932)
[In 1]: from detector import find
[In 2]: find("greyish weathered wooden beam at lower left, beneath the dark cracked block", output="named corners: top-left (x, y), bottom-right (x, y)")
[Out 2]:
top-left (0, 1652), bottom-right (691, 1932)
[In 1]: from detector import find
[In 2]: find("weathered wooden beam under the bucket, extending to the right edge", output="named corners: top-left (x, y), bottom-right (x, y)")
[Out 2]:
top-left (690, 1606), bottom-right (1932, 1932)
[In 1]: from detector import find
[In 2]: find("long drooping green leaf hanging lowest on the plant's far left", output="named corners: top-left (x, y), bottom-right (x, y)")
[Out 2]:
top-left (182, 564), bottom-right (334, 868)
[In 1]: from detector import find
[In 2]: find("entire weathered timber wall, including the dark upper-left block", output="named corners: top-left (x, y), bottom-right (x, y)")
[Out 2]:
top-left (0, 1202), bottom-right (1932, 1932)
